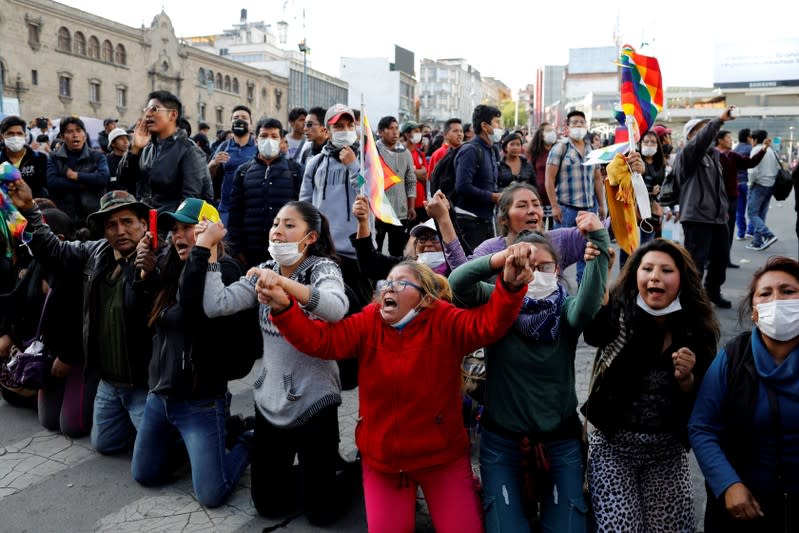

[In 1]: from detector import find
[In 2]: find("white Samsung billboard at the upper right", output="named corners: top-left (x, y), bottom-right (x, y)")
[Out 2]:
top-left (713, 38), bottom-right (799, 88)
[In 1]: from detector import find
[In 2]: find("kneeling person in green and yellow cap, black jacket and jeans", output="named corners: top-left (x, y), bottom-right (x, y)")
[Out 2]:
top-left (131, 198), bottom-right (250, 507)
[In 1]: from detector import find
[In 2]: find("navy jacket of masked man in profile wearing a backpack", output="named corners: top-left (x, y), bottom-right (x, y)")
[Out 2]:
top-left (455, 137), bottom-right (499, 220)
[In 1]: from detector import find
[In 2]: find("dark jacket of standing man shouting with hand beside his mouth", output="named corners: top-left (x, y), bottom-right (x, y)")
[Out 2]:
top-left (117, 130), bottom-right (214, 213)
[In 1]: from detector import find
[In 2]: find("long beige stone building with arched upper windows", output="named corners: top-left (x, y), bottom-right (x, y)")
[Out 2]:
top-left (0, 0), bottom-right (288, 131)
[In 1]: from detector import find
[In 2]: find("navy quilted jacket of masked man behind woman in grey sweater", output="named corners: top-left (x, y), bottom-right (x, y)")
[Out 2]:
top-left (227, 154), bottom-right (304, 266)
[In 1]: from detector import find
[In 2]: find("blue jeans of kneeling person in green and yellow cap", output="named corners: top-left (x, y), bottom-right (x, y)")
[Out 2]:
top-left (130, 392), bottom-right (250, 507)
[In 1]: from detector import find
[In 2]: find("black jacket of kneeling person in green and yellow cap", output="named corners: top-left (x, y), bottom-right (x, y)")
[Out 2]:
top-left (149, 250), bottom-right (252, 399)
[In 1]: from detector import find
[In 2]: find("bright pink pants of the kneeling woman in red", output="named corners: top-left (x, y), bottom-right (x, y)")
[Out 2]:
top-left (363, 456), bottom-right (483, 533)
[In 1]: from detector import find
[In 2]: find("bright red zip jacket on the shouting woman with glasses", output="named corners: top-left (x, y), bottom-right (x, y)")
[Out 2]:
top-left (272, 280), bottom-right (526, 473)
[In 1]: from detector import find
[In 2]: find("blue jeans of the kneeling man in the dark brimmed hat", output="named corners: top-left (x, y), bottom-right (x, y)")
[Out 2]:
top-left (91, 379), bottom-right (147, 455)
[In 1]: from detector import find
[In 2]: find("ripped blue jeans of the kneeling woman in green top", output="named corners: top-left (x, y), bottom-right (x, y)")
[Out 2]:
top-left (480, 428), bottom-right (588, 533)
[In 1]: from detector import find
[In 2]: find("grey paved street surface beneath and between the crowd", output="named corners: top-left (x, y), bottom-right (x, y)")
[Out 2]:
top-left (0, 198), bottom-right (797, 532)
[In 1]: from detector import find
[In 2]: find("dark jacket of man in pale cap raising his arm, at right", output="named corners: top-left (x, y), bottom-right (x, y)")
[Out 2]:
top-left (674, 118), bottom-right (728, 224)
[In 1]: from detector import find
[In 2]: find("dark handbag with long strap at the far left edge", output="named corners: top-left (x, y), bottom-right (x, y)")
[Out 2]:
top-left (0, 289), bottom-right (53, 396)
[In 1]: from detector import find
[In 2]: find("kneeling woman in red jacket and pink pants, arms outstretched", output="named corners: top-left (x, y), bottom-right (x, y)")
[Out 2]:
top-left (258, 247), bottom-right (533, 533)
